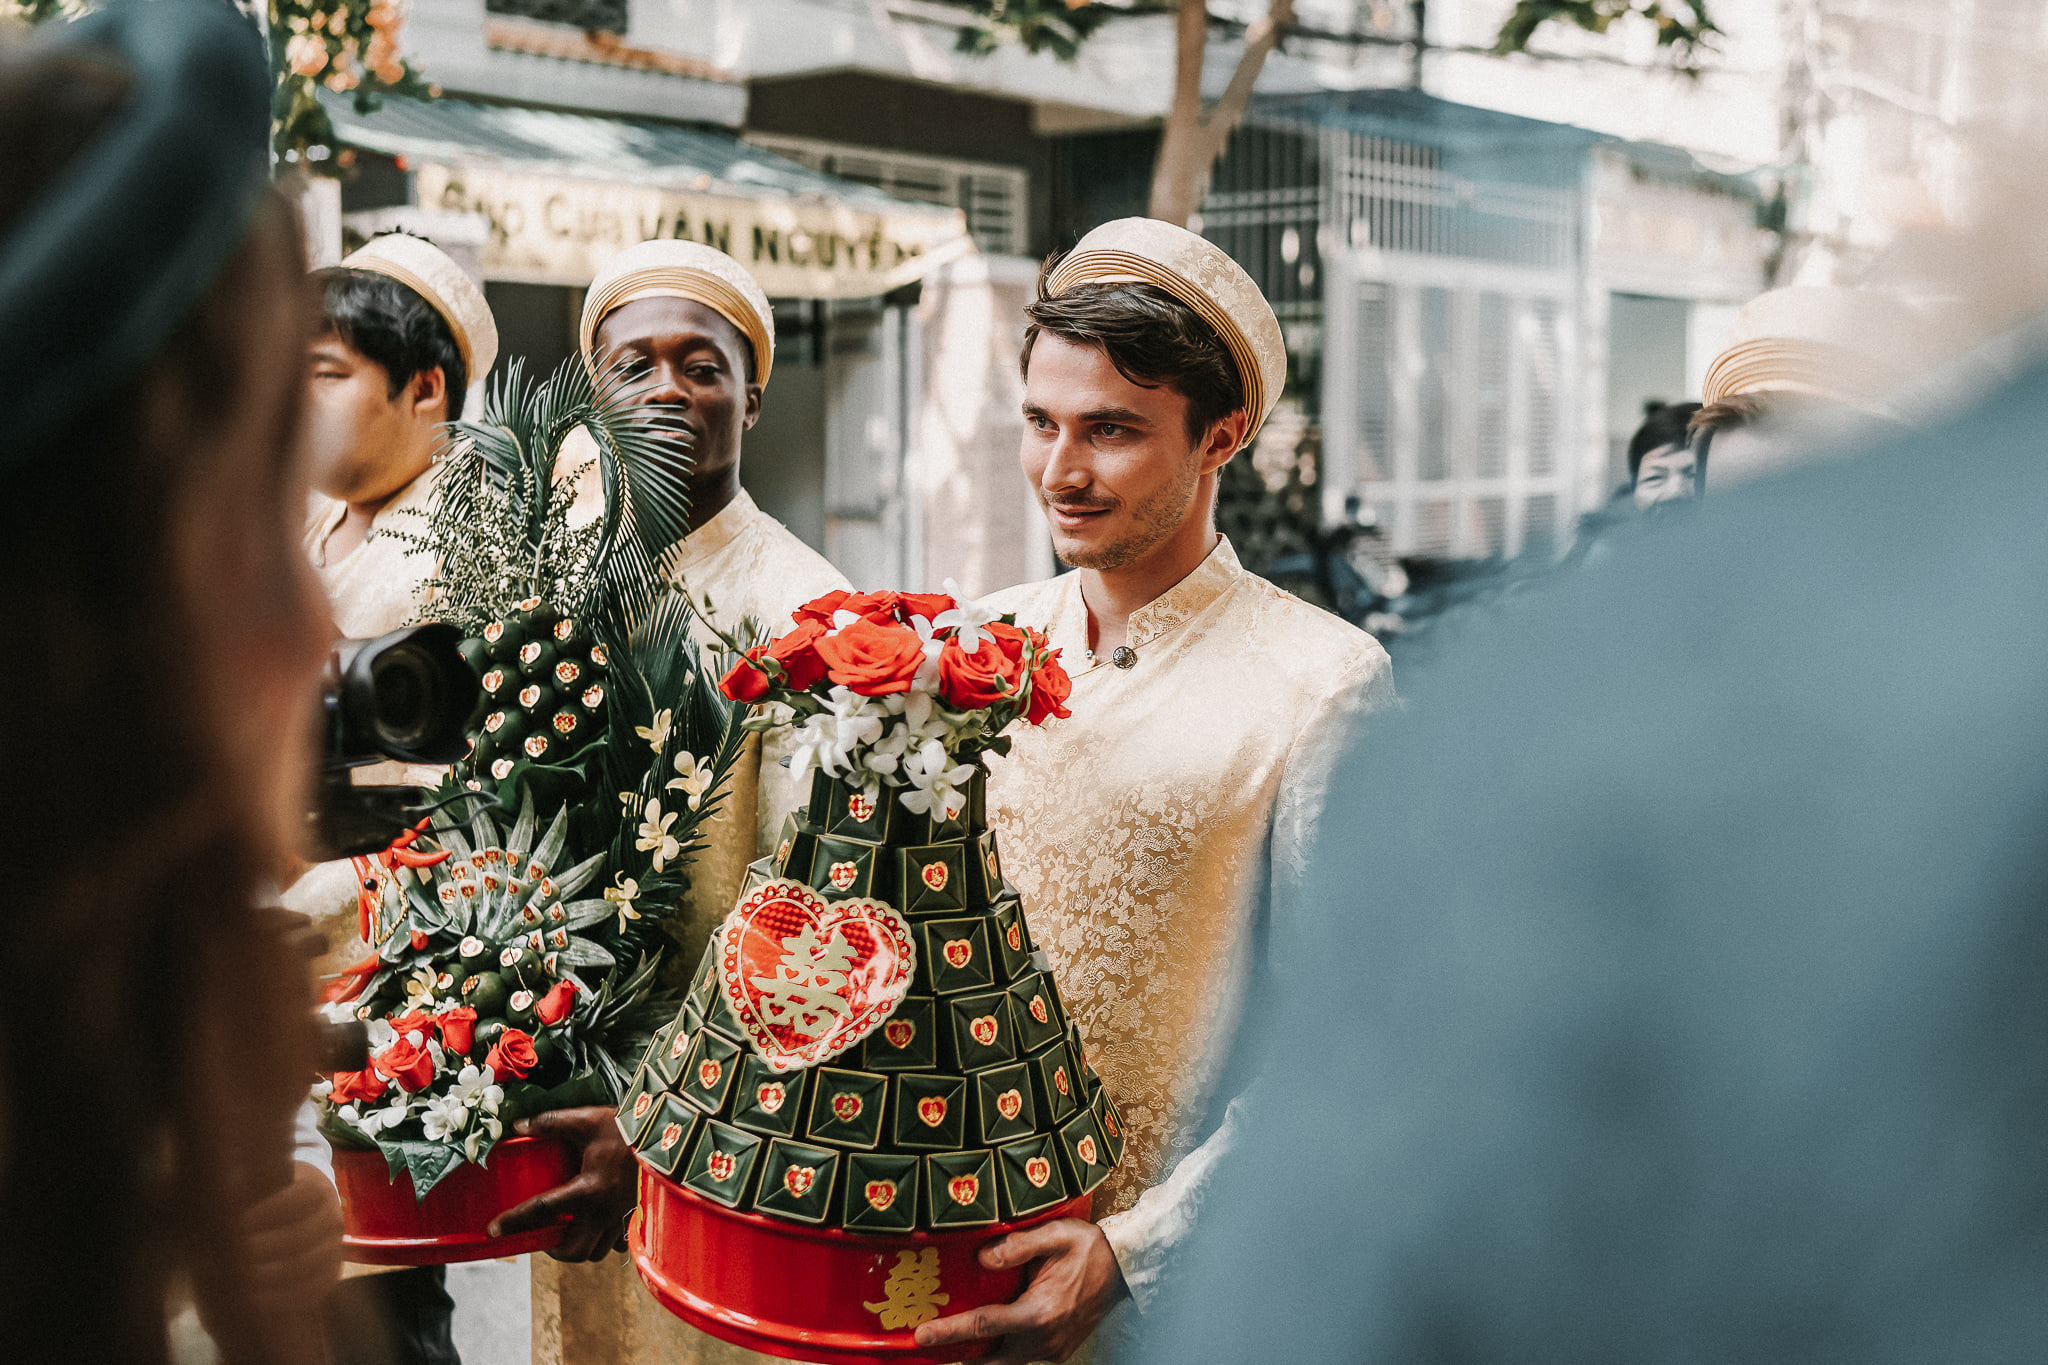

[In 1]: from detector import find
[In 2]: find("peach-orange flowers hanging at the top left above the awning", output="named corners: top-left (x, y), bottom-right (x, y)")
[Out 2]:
top-left (270, 0), bottom-right (440, 160)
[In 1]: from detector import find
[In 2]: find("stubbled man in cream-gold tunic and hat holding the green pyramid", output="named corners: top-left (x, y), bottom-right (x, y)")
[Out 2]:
top-left (918, 219), bottom-right (1393, 1363)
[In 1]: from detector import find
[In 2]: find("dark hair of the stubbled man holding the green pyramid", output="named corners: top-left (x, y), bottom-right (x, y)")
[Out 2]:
top-left (1018, 256), bottom-right (1245, 440)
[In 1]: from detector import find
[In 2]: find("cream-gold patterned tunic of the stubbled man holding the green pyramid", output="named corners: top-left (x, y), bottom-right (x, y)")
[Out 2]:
top-left (989, 538), bottom-right (1393, 1297)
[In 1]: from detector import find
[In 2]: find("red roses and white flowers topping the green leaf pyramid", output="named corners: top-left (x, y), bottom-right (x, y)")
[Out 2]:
top-left (719, 579), bottom-right (1073, 821)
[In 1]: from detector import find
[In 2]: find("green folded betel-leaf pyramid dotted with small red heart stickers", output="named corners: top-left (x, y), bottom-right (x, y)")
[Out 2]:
top-left (618, 774), bottom-right (1124, 1236)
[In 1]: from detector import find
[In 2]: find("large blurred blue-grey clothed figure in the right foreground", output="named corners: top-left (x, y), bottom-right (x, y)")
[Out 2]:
top-left (1137, 327), bottom-right (2048, 1365)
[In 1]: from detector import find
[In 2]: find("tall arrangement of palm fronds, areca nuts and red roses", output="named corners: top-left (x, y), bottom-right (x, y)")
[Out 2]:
top-left (315, 358), bottom-right (745, 1197)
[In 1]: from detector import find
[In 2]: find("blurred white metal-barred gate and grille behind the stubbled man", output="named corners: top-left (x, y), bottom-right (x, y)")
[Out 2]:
top-left (1200, 115), bottom-right (1583, 557)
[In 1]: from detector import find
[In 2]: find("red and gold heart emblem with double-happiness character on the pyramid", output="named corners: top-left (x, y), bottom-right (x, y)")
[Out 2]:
top-left (717, 878), bottom-right (918, 1072)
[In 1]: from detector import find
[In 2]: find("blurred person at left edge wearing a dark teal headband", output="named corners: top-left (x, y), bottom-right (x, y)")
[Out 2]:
top-left (0, 0), bottom-right (340, 1363)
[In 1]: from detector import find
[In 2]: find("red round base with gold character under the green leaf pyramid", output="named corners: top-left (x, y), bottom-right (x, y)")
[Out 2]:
top-left (631, 1166), bottom-right (1090, 1365)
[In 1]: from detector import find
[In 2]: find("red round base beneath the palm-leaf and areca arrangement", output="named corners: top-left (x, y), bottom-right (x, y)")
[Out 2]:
top-left (334, 1138), bottom-right (575, 1265)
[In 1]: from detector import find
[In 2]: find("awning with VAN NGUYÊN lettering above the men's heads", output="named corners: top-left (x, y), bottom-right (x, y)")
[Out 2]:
top-left (322, 90), bottom-right (973, 299)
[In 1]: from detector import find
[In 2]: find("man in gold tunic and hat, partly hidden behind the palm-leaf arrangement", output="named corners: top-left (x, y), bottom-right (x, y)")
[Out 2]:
top-left (503, 239), bottom-right (848, 1365)
